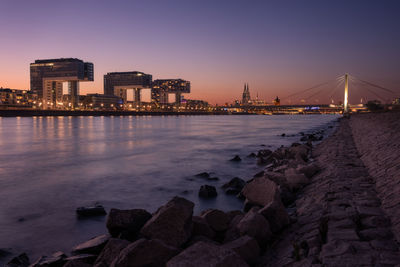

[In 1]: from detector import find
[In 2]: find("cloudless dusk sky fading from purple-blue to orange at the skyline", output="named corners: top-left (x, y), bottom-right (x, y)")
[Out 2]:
top-left (0, 0), bottom-right (400, 104)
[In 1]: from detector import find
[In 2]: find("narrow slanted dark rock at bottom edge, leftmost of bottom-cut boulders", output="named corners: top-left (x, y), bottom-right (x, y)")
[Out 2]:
top-left (94, 238), bottom-right (130, 267)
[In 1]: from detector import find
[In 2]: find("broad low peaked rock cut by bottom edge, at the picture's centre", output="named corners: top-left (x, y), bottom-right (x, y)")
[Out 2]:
top-left (166, 241), bottom-right (248, 267)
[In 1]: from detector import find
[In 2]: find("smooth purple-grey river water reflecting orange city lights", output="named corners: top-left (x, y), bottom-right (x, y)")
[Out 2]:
top-left (0, 115), bottom-right (337, 263)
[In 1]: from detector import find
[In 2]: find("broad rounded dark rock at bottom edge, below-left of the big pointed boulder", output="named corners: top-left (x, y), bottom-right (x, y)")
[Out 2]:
top-left (111, 238), bottom-right (179, 267)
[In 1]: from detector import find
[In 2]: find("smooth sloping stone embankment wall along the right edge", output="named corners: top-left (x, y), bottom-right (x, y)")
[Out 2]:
top-left (350, 112), bottom-right (400, 241)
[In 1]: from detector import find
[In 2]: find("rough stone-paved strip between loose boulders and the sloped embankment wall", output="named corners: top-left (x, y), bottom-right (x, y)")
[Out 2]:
top-left (261, 119), bottom-right (400, 266)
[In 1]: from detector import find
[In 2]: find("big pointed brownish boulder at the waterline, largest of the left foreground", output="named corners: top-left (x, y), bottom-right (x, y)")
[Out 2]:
top-left (140, 197), bottom-right (194, 247)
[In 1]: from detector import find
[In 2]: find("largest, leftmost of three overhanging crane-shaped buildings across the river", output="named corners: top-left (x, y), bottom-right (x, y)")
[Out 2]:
top-left (30, 58), bottom-right (94, 109)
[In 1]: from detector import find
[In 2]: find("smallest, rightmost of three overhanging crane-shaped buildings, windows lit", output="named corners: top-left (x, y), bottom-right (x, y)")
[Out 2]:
top-left (151, 79), bottom-right (190, 105)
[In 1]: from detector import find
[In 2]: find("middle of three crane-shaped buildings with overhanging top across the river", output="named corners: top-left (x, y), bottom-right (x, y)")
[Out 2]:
top-left (104, 71), bottom-right (153, 104)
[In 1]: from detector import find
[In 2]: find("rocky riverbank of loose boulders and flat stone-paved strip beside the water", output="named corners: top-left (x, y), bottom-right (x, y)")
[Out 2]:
top-left (3, 112), bottom-right (400, 267)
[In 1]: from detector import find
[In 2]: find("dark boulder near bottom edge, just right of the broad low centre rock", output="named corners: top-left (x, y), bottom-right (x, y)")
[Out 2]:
top-left (223, 235), bottom-right (260, 265)
